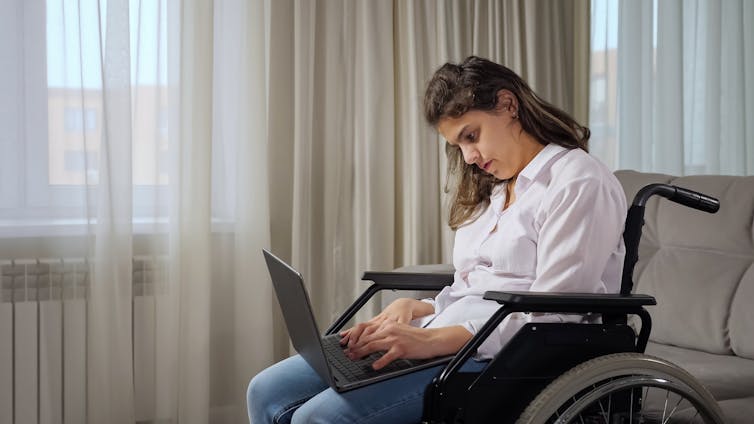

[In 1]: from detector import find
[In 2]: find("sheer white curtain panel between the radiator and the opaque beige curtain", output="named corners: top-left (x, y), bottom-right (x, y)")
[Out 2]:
top-left (154, 0), bottom-right (274, 423)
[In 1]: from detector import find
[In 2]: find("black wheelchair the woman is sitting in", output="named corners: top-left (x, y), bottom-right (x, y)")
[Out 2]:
top-left (326, 184), bottom-right (725, 424)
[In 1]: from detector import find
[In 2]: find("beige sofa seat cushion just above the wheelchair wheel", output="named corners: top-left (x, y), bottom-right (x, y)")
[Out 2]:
top-left (646, 342), bottom-right (754, 401)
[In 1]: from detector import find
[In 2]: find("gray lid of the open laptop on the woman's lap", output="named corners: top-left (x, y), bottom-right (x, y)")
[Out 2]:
top-left (263, 250), bottom-right (335, 387)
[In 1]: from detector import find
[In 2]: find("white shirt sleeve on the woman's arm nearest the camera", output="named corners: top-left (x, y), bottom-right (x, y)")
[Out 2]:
top-left (463, 177), bottom-right (626, 359)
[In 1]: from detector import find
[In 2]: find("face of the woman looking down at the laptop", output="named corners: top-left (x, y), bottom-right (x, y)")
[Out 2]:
top-left (437, 90), bottom-right (544, 180)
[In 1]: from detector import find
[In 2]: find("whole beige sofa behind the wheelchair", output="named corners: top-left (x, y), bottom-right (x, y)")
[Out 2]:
top-left (616, 171), bottom-right (754, 423)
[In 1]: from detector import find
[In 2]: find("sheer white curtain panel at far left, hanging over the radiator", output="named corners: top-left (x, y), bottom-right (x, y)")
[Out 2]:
top-left (0, 1), bottom-right (141, 422)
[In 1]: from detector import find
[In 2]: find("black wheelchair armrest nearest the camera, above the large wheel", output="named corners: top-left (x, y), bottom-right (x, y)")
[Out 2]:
top-left (484, 291), bottom-right (657, 312)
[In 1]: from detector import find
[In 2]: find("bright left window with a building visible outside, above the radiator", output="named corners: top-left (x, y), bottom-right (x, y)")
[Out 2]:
top-left (0, 0), bottom-right (168, 236)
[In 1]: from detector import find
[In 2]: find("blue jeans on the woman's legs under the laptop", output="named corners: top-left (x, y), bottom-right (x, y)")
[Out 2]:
top-left (246, 355), bottom-right (487, 424)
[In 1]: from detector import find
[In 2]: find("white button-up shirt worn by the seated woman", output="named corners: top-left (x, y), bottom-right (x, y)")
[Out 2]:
top-left (416, 144), bottom-right (627, 358)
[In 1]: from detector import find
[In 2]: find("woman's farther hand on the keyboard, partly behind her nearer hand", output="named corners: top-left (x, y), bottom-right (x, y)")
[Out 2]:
top-left (340, 298), bottom-right (435, 347)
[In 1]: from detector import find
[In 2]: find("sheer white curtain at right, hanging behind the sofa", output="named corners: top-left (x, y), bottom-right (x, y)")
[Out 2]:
top-left (590, 0), bottom-right (754, 175)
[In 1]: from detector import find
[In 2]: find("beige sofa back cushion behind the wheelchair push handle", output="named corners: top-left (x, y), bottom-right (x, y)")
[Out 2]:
top-left (616, 171), bottom-right (754, 355)
